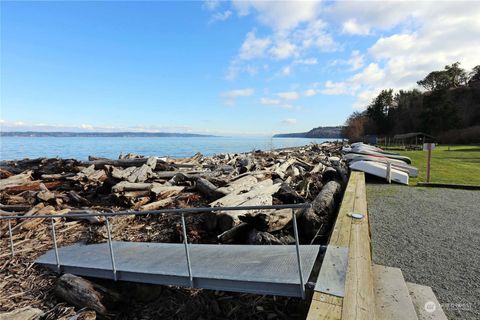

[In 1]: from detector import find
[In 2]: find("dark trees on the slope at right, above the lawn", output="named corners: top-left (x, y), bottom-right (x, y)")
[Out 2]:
top-left (343, 62), bottom-right (480, 143)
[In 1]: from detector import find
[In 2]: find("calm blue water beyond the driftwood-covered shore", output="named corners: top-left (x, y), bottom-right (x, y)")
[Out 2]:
top-left (0, 137), bottom-right (331, 160)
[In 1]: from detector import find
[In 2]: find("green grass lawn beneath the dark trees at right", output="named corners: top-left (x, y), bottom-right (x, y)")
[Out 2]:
top-left (395, 146), bottom-right (480, 185)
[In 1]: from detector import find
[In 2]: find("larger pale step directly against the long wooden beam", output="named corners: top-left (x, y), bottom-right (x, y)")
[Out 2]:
top-left (373, 265), bottom-right (418, 320)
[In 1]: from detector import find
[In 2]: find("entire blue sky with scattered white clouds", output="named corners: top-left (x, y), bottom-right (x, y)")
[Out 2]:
top-left (0, 0), bottom-right (480, 134)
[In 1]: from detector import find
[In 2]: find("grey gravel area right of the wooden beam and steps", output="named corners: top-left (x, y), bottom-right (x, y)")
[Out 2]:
top-left (367, 183), bottom-right (480, 319)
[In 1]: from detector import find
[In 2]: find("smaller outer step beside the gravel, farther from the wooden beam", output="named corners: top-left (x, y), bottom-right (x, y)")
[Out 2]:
top-left (406, 282), bottom-right (447, 320)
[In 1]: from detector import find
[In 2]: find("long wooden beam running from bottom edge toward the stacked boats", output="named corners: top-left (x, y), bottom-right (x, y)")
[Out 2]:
top-left (342, 172), bottom-right (375, 320)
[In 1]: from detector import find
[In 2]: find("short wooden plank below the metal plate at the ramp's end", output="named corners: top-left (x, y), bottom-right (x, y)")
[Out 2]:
top-left (307, 292), bottom-right (343, 320)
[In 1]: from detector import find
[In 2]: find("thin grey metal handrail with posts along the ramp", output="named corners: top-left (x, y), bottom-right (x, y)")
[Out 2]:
top-left (0, 203), bottom-right (311, 299)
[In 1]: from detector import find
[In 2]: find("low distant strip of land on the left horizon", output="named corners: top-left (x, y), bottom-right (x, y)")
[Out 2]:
top-left (0, 131), bottom-right (214, 138)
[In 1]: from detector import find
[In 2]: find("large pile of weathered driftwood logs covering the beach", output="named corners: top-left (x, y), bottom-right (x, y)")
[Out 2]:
top-left (0, 144), bottom-right (348, 319)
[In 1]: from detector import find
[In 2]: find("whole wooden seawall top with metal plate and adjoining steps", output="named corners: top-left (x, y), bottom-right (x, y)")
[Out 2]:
top-left (307, 171), bottom-right (447, 320)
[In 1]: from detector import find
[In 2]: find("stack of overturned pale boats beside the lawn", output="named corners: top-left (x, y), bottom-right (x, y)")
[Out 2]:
top-left (342, 142), bottom-right (418, 185)
